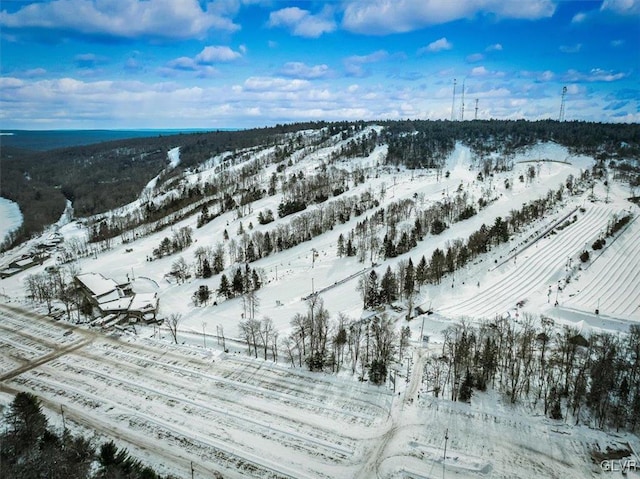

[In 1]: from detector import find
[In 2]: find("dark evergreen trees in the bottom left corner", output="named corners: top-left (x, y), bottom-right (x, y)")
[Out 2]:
top-left (0, 392), bottom-right (175, 479)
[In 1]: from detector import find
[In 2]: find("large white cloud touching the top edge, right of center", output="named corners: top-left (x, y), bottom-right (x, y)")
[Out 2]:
top-left (342, 0), bottom-right (555, 35)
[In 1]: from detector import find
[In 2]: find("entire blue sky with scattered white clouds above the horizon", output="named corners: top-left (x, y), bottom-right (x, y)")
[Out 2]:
top-left (0, 0), bottom-right (640, 129)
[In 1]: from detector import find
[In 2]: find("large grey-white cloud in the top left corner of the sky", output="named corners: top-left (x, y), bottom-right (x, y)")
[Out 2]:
top-left (0, 0), bottom-right (240, 39)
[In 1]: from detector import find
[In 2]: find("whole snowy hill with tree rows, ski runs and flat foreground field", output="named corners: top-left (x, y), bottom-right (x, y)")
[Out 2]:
top-left (0, 122), bottom-right (640, 478)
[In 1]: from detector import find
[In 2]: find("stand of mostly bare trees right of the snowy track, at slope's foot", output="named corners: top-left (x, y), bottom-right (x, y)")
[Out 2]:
top-left (424, 314), bottom-right (640, 432)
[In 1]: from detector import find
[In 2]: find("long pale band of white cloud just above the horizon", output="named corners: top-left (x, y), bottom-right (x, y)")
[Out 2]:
top-left (0, 72), bottom-right (640, 128)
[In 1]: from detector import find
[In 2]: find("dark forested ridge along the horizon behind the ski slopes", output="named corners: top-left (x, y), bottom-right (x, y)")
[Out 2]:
top-left (0, 120), bottom-right (640, 248)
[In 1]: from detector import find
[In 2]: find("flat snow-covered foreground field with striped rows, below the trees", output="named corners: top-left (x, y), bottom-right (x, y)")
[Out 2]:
top-left (0, 305), bottom-right (639, 479)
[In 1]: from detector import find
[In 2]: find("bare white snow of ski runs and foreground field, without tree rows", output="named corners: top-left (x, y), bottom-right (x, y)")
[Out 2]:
top-left (0, 129), bottom-right (640, 478)
